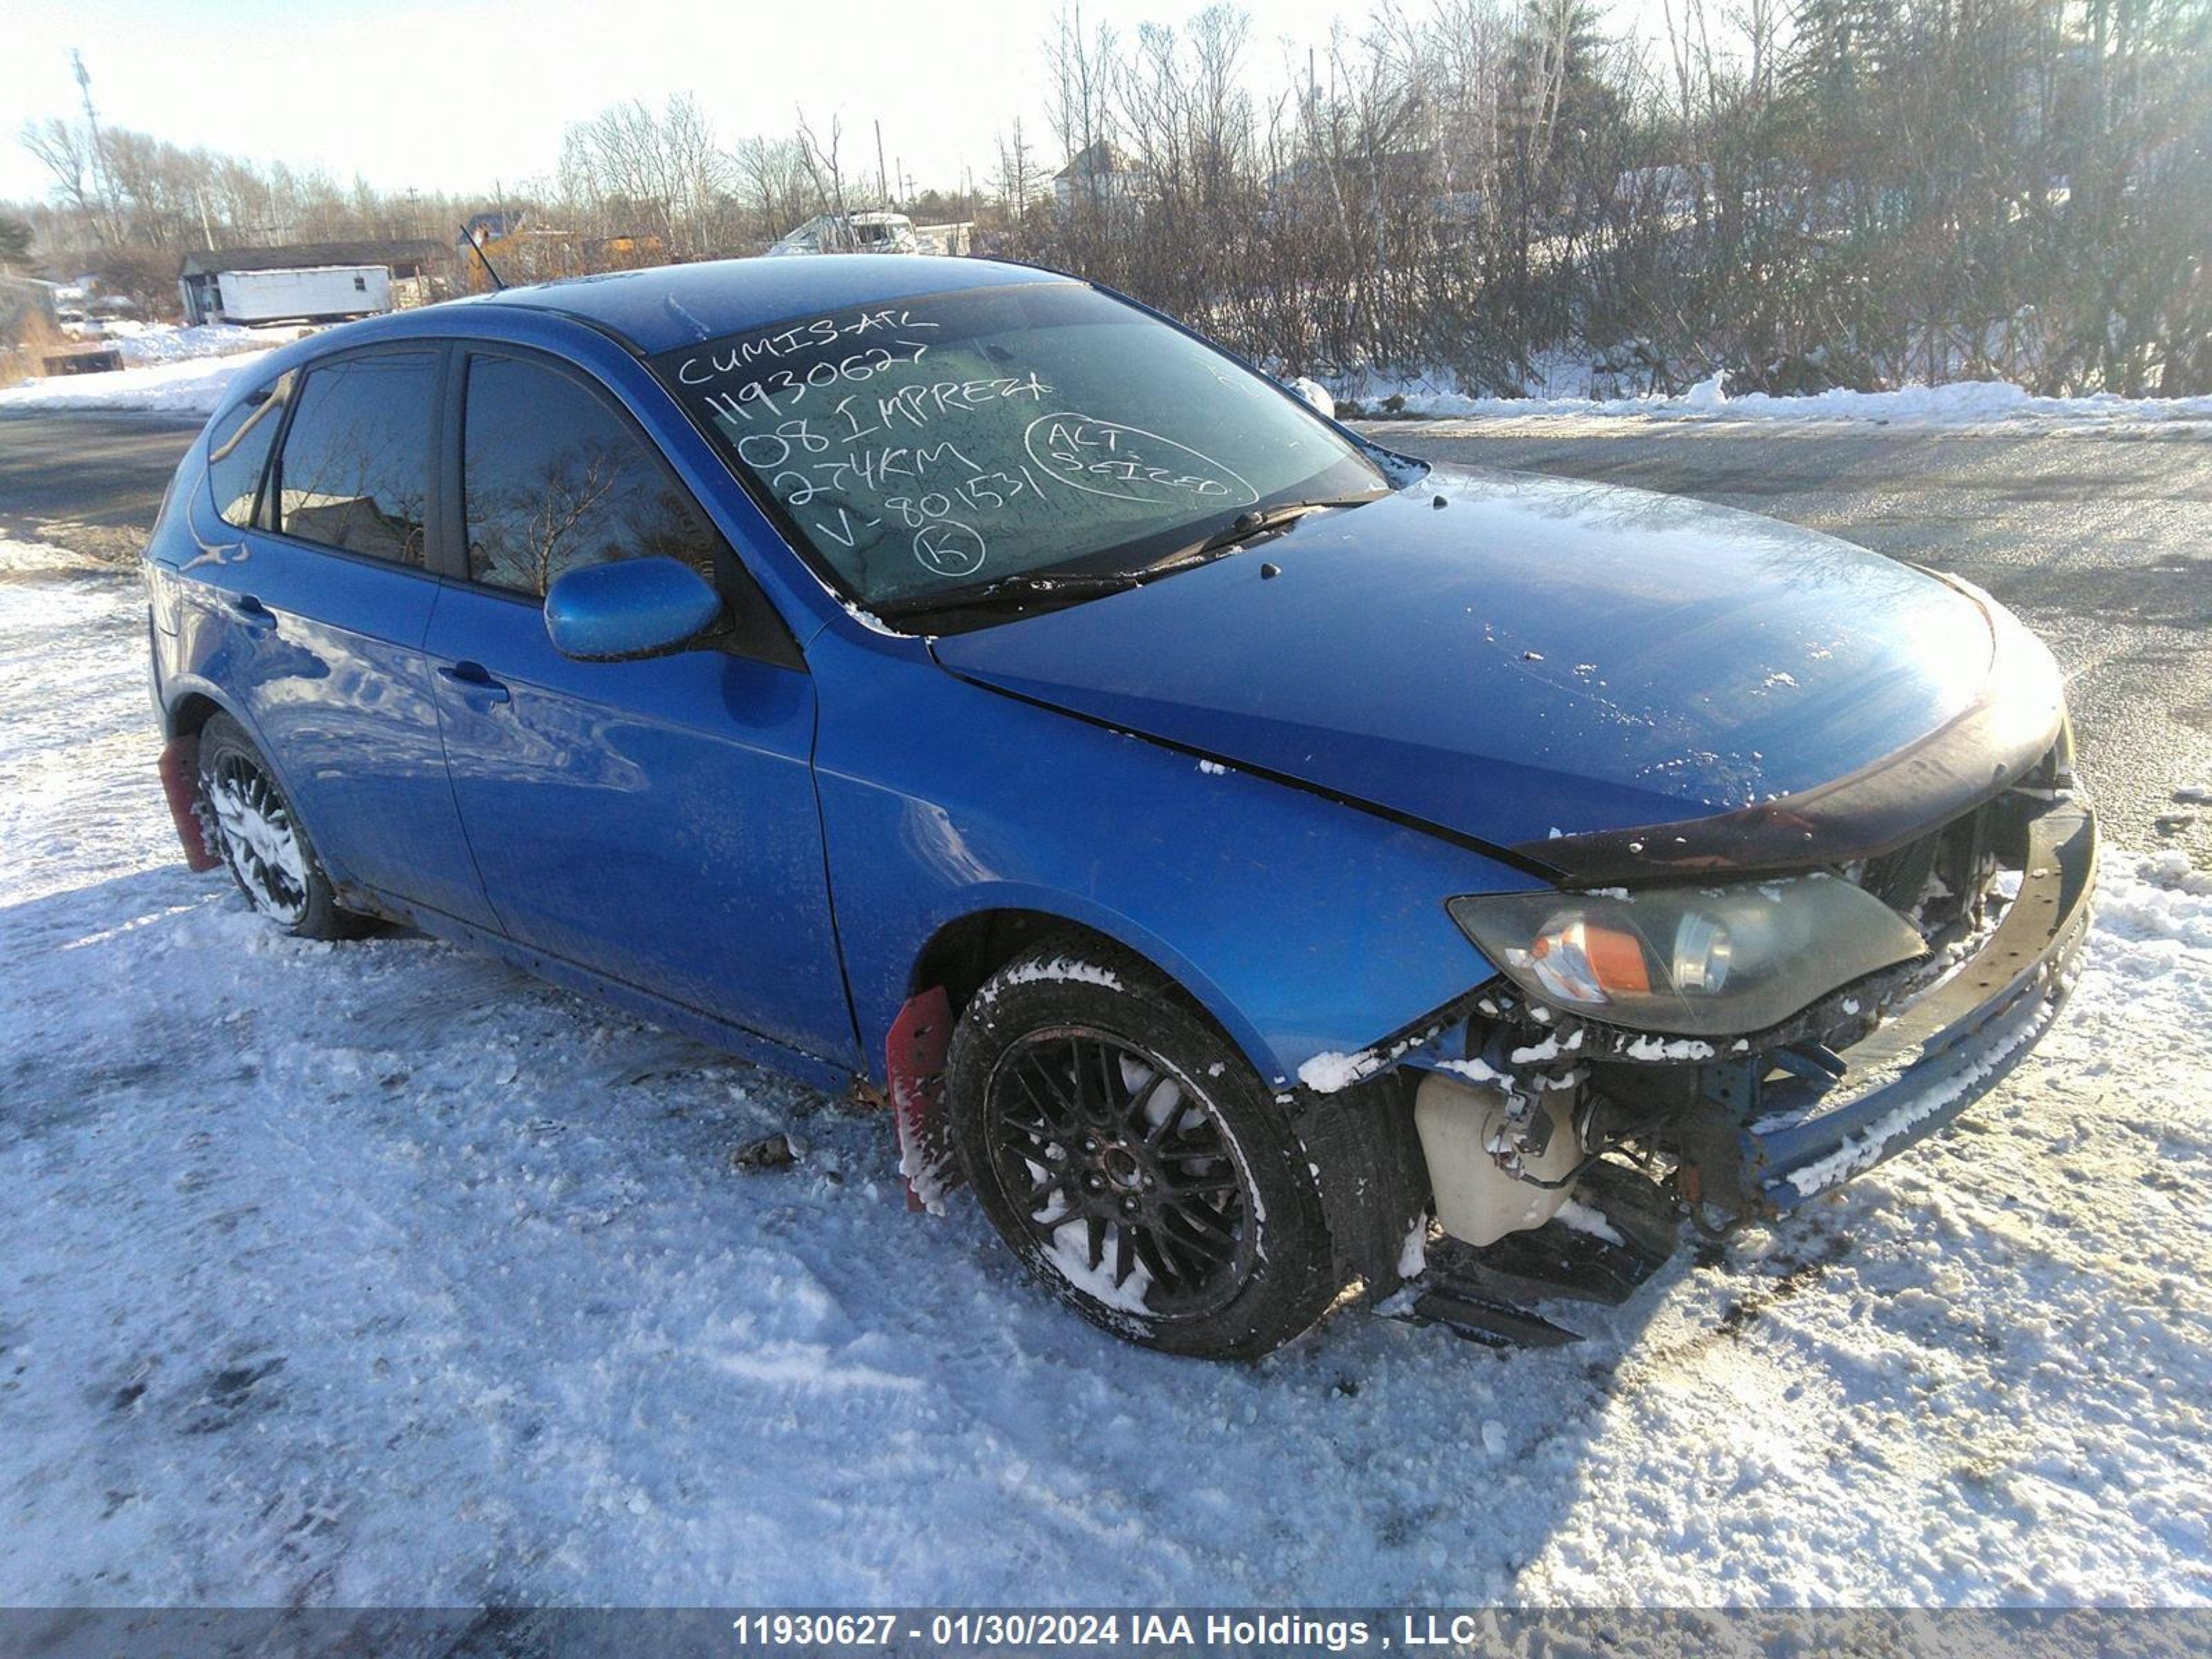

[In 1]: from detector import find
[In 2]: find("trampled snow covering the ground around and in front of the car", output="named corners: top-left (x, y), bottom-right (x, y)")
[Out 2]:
top-left (12, 546), bottom-right (2212, 1606)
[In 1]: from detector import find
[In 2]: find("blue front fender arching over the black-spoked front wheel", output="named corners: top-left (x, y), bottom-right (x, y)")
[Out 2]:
top-left (807, 632), bottom-right (1533, 1088)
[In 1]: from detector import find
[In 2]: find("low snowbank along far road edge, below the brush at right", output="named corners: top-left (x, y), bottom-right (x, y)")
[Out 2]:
top-left (1360, 374), bottom-right (2212, 427)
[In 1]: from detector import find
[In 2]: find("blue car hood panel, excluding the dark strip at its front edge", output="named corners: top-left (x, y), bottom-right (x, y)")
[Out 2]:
top-left (933, 469), bottom-right (1993, 863)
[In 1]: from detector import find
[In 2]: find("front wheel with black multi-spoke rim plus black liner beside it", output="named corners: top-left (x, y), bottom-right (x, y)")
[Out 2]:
top-left (947, 940), bottom-right (1427, 1358)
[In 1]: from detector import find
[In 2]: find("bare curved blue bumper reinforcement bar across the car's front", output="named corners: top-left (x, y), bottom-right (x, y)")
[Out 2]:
top-left (1685, 796), bottom-right (2097, 1215)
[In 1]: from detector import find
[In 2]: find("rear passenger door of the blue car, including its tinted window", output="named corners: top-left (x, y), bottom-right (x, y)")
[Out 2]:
top-left (188, 345), bottom-right (494, 927)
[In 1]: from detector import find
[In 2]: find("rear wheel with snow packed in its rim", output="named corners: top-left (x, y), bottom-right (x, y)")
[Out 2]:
top-left (199, 715), bottom-right (374, 940)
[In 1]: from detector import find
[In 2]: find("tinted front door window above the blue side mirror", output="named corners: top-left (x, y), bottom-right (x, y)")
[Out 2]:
top-left (460, 356), bottom-right (715, 597)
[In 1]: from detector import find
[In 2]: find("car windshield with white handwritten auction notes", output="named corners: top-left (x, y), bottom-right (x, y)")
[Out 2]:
top-left (655, 281), bottom-right (1389, 617)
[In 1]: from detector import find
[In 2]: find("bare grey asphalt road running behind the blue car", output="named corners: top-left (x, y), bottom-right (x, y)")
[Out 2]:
top-left (0, 413), bottom-right (2212, 867)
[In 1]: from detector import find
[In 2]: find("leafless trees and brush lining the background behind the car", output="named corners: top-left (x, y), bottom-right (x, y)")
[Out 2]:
top-left (11, 0), bottom-right (2212, 394)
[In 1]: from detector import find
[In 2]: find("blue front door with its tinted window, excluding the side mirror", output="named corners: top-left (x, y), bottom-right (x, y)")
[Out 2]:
top-left (427, 350), bottom-right (856, 1064)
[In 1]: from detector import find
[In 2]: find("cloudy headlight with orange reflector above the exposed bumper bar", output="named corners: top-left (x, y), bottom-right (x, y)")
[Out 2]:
top-left (1451, 874), bottom-right (1927, 1038)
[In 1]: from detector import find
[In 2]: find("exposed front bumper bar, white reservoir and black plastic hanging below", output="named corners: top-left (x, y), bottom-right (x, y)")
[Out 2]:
top-left (1385, 789), bottom-right (2097, 1345)
